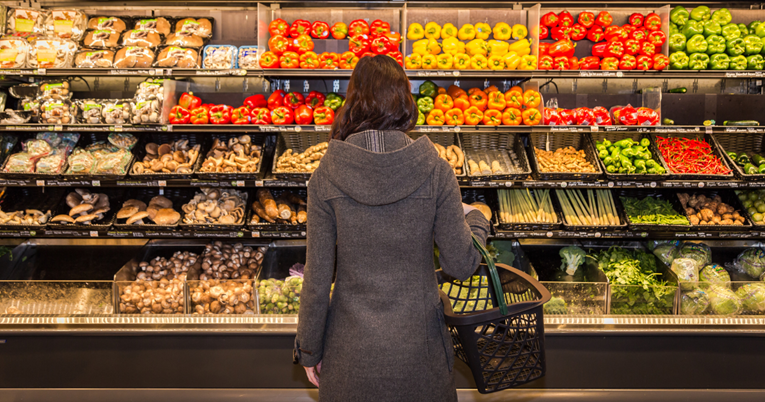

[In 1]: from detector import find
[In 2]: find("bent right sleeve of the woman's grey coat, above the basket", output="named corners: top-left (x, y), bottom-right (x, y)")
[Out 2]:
top-left (434, 162), bottom-right (489, 280)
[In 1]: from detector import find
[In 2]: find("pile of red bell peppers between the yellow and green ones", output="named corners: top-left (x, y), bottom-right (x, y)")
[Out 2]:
top-left (539, 10), bottom-right (669, 70)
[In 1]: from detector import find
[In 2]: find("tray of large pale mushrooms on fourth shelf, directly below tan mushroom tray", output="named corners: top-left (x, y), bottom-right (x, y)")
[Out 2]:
top-left (181, 187), bottom-right (247, 229)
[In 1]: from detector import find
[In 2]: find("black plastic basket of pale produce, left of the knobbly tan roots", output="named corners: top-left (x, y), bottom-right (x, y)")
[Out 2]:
top-left (461, 132), bottom-right (531, 180)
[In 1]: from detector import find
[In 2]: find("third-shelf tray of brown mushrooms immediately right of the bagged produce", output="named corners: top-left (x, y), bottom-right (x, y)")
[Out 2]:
top-left (130, 136), bottom-right (201, 178)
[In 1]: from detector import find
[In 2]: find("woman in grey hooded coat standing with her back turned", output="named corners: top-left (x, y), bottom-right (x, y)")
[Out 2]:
top-left (295, 56), bottom-right (489, 402)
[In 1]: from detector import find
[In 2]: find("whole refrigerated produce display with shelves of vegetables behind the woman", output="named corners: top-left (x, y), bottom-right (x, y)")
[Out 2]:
top-left (0, 0), bottom-right (765, 400)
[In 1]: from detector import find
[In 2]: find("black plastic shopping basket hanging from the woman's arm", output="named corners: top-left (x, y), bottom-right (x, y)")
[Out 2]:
top-left (438, 236), bottom-right (550, 394)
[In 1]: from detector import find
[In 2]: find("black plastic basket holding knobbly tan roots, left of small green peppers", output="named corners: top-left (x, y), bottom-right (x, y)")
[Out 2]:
top-left (529, 133), bottom-right (603, 180)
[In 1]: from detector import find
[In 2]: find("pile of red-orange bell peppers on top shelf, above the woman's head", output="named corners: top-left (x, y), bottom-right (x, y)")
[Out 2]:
top-left (260, 18), bottom-right (404, 70)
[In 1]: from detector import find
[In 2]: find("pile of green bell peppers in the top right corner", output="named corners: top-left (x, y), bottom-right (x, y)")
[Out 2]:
top-left (669, 6), bottom-right (765, 70)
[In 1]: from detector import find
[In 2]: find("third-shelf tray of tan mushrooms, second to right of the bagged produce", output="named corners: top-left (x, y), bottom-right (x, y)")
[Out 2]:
top-left (196, 135), bottom-right (263, 179)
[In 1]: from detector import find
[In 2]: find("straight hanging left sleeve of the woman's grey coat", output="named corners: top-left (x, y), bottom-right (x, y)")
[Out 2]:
top-left (295, 179), bottom-right (337, 367)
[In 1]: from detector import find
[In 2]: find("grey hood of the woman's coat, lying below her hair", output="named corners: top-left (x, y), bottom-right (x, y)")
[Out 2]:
top-left (321, 136), bottom-right (439, 205)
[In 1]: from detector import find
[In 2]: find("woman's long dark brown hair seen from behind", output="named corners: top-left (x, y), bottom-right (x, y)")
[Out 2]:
top-left (332, 55), bottom-right (418, 141)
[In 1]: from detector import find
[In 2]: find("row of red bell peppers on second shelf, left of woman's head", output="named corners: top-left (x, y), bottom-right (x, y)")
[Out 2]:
top-left (170, 90), bottom-right (345, 125)
